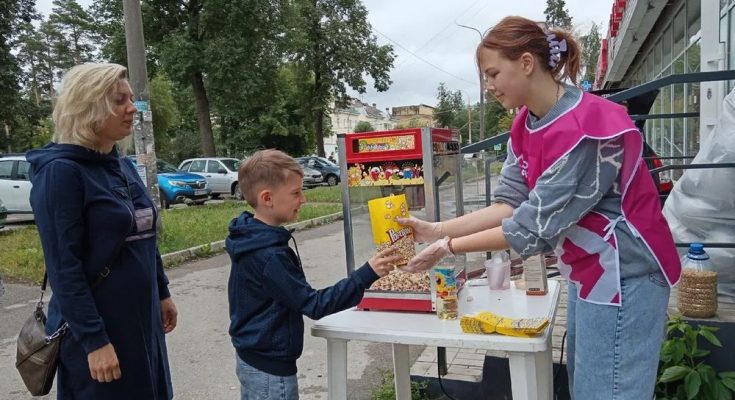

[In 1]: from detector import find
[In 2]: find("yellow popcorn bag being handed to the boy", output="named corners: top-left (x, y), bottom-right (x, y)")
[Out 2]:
top-left (368, 194), bottom-right (416, 266)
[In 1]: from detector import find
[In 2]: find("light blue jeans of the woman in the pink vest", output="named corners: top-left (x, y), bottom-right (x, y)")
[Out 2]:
top-left (567, 272), bottom-right (670, 400)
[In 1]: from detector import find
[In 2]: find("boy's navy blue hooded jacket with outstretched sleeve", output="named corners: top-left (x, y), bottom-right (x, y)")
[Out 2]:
top-left (225, 211), bottom-right (378, 376)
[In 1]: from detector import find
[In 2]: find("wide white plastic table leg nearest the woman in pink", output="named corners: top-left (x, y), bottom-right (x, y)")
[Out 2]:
top-left (508, 346), bottom-right (554, 400)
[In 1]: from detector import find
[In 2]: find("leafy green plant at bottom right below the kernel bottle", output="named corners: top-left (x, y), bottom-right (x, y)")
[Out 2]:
top-left (656, 316), bottom-right (735, 400)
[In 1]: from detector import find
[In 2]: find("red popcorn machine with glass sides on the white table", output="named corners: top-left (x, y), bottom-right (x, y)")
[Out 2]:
top-left (337, 128), bottom-right (466, 312)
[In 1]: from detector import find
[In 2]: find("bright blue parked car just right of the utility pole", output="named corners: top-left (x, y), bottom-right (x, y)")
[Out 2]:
top-left (128, 156), bottom-right (211, 209)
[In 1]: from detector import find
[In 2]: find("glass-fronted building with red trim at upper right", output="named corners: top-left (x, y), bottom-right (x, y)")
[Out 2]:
top-left (595, 0), bottom-right (735, 162)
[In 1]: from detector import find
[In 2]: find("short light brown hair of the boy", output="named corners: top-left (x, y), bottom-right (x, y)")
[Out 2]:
top-left (237, 149), bottom-right (304, 208)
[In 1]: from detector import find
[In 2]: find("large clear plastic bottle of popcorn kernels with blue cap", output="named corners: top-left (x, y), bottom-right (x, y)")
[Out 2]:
top-left (678, 243), bottom-right (717, 318)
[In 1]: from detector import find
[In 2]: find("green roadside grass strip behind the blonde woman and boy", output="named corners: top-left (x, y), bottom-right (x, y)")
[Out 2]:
top-left (0, 200), bottom-right (342, 283)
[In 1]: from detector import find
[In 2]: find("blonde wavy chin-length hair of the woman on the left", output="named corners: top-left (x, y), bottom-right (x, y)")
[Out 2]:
top-left (53, 64), bottom-right (128, 151)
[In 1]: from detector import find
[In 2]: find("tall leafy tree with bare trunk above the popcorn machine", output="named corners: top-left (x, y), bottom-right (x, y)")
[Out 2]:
top-left (290, 0), bottom-right (395, 157)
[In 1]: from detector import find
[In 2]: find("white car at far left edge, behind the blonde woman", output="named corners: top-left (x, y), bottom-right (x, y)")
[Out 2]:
top-left (0, 154), bottom-right (33, 214)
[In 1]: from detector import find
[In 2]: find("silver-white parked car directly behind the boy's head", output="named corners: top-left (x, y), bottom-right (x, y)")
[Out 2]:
top-left (179, 157), bottom-right (242, 200)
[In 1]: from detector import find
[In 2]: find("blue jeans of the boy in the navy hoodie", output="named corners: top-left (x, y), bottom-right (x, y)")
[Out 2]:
top-left (236, 357), bottom-right (299, 400)
